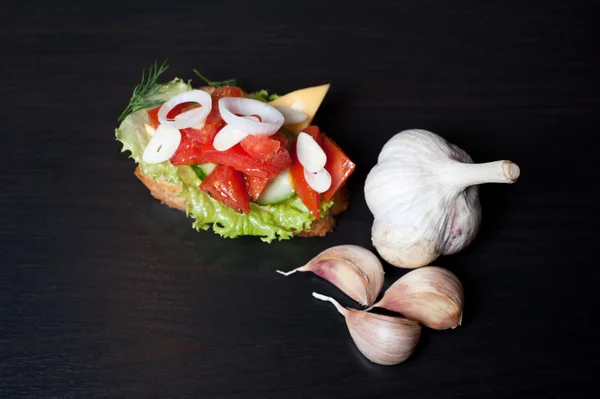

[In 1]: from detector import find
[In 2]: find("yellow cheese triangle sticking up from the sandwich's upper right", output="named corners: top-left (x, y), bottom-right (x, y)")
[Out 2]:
top-left (269, 83), bottom-right (330, 134)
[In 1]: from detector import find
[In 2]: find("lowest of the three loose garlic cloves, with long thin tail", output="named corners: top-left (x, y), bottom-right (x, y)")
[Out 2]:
top-left (313, 292), bottom-right (421, 366)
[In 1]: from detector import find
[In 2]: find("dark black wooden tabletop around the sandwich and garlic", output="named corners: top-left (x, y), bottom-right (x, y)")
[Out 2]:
top-left (0, 0), bottom-right (600, 398)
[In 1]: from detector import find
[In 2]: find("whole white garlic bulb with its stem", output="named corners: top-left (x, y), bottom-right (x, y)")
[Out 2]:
top-left (364, 130), bottom-right (520, 268)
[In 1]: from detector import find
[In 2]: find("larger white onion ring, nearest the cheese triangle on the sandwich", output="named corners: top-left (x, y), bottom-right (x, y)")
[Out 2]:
top-left (219, 97), bottom-right (284, 136)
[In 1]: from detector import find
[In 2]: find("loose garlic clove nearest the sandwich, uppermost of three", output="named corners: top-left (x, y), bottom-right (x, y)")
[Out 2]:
top-left (277, 245), bottom-right (384, 306)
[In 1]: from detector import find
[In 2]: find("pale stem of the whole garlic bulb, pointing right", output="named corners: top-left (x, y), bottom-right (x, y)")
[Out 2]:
top-left (440, 161), bottom-right (521, 190)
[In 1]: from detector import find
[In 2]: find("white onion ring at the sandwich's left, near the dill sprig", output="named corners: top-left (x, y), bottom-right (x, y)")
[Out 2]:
top-left (158, 90), bottom-right (212, 129)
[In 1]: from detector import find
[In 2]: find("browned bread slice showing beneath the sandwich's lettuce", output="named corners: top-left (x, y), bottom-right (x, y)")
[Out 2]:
top-left (134, 166), bottom-right (348, 237)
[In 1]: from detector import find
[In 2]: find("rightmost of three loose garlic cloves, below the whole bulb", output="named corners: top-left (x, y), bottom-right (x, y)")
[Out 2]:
top-left (372, 266), bottom-right (464, 330)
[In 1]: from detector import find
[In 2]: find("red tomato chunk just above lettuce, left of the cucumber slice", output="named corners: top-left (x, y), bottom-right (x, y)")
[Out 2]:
top-left (200, 165), bottom-right (250, 213)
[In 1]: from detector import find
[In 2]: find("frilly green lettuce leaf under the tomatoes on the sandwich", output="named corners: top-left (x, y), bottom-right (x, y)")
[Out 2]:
top-left (115, 79), bottom-right (333, 242)
